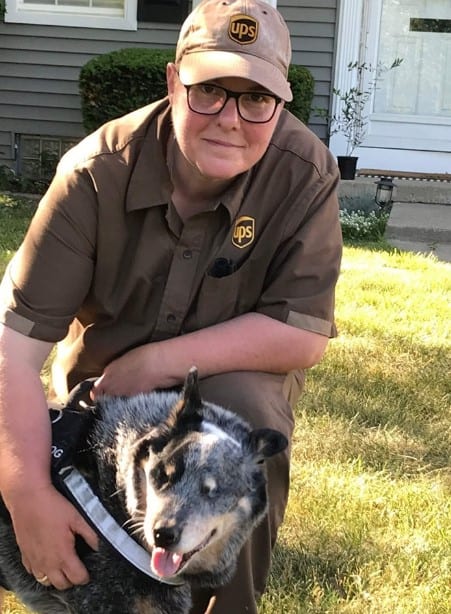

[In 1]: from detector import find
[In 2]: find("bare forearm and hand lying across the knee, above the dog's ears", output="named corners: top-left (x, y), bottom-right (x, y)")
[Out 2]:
top-left (94, 313), bottom-right (328, 395)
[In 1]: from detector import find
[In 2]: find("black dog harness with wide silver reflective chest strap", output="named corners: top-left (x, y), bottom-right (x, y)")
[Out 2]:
top-left (0, 380), bottom-right (184, 588)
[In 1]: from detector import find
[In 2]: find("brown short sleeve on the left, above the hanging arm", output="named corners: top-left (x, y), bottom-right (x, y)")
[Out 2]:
top-left (0, 169), bottom-right (97, 342)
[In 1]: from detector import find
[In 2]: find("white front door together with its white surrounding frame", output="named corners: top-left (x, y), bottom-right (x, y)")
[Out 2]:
top-left (328, 0), bottom-right (451, 173)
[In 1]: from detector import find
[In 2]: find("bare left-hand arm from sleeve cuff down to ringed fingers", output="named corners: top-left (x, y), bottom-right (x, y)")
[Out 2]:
top-left (0, 324), bottom-right (97, 589)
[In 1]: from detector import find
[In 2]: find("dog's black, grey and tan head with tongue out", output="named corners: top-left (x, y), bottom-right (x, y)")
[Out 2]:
top-left (127, 369), bottom-right (287, 585)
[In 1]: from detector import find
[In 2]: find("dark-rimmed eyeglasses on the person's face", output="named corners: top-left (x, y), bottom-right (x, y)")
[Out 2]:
top-left (185, 83), bottom-right (282, 124)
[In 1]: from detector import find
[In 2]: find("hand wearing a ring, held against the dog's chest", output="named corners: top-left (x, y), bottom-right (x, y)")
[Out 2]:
top-left (8, 485), bottom-right (98, 590)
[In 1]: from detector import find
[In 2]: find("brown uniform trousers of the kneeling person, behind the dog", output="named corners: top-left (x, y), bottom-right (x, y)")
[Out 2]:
top-left (191, 371), bottom-right (303, 614)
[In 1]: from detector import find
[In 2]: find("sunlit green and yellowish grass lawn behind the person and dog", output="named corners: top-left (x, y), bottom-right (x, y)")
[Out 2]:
top-left (0, 198), bottom-right (451, 614)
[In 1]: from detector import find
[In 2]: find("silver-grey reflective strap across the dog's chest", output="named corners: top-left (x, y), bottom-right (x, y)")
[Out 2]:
top-left (58, 466), bottom-right (185, 586)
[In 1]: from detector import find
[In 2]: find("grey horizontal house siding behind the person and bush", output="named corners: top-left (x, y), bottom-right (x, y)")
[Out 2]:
top-left (0, 0), bottom-right (338, 167)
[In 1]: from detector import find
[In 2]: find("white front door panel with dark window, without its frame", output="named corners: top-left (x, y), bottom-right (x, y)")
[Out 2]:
top-left (368, 0), bottom-right (451, 150)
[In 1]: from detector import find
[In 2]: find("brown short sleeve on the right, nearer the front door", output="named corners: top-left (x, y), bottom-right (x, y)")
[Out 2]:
top-left (257, 170), bottom-right (342, 337)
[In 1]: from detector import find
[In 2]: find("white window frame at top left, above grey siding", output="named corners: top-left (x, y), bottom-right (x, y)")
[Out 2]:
top-left (5, 0), bottom-right (138, 30)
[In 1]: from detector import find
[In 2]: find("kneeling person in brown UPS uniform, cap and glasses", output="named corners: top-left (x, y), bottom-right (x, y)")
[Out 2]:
top-left (0, 0), bottom-right (341, 614)
